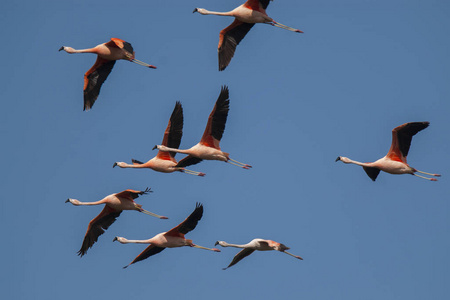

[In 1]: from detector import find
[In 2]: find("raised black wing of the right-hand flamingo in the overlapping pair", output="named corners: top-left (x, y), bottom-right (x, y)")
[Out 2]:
top-left (200, 86), bottom-right (230, 149)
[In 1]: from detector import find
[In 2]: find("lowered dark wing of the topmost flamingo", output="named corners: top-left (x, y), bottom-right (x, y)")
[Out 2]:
top-left (217, 19), bottom-right (255, 71)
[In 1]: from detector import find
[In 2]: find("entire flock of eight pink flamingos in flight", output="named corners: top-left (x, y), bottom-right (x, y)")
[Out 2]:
top-left (59, 0), bottom-right (441, 269)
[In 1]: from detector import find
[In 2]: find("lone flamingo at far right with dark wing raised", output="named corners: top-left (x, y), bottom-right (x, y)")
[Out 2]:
top-left (336, 122), bottom-right (441, 181)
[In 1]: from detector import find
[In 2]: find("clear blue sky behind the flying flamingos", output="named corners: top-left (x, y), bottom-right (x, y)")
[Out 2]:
top-left (0, 0), bottom-right (450, 300)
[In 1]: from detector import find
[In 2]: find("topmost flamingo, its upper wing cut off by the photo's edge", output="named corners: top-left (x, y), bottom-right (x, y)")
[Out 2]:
top-left (193, 0), bottom-right (303, 71)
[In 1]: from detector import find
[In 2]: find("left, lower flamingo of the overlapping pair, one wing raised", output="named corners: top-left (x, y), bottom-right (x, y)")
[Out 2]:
top-left (113, 102), bottom-right (205, 176)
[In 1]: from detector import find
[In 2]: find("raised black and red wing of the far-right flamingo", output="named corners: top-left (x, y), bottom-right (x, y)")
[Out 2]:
top-left (387, 122), bottom-right (430, 163)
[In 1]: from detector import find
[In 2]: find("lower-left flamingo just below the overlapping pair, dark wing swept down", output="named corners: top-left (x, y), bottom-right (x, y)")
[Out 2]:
top-left (66, 188), bottom-right (167, 257)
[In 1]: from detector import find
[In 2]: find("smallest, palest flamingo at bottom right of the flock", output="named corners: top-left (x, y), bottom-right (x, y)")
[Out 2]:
top-left (216, 239), bottom-right (303, 270)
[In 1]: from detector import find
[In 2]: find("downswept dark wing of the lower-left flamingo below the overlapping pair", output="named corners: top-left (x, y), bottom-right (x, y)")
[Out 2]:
top-left (78, 205), bottom-right (122, 257)
